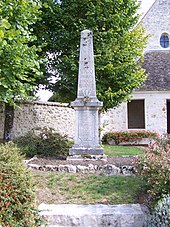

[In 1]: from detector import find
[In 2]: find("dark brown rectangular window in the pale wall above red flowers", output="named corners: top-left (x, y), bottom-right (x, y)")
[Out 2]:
top-left (127, 100), bottom-right (145, 129)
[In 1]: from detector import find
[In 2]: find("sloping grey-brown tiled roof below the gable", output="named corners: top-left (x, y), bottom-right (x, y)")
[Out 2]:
top-left (138, 51), bottom-right (170, 91)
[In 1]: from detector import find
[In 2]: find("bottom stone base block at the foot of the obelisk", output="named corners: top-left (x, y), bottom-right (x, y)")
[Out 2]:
top-left (69, 146), bottom-right (104, 156)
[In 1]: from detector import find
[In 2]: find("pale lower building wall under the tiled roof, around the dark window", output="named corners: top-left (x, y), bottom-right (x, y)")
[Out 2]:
top-left (101, 91), bottom-right (170, 134)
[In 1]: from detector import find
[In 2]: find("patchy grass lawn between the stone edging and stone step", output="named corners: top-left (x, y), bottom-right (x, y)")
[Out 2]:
top-left (34, 172), bottom-right (147, 204)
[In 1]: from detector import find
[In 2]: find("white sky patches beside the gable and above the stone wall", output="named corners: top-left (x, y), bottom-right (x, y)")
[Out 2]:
top-left (36, 0), bottom-right (155, 101)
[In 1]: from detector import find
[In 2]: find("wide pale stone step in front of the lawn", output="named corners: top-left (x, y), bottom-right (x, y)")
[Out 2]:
top-left (38, 204), bottom-right (149, 227)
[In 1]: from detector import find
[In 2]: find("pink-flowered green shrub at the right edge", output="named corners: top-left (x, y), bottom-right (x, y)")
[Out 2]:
top-left (136, 136), bottom-right (170, 202)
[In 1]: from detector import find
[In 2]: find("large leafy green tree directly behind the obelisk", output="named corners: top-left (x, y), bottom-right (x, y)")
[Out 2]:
top-left (36, 0), bottom-right (147, 109)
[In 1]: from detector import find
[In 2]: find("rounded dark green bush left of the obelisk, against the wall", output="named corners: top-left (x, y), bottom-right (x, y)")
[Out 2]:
top-left (14, 127), bottom-right (71, 157)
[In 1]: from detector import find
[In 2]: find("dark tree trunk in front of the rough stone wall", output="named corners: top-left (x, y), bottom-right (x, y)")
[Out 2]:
top-left (3, 103), bottom-right (14, 143)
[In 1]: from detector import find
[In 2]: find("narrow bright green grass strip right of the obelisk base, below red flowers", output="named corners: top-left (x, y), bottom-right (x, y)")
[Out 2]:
top-left (103, 145), bottom-right (144, 156)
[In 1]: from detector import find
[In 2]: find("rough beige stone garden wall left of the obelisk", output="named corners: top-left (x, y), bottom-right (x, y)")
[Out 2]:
top-left (0, 102), bottom-right (75, 138)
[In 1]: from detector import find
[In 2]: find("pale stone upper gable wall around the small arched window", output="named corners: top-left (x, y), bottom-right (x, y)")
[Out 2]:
top-left (142, 0), bottom-right (170, 51)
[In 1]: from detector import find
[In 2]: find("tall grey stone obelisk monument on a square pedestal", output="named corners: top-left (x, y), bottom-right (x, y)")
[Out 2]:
top-left (69, 30), bottom-right (103, 155)
